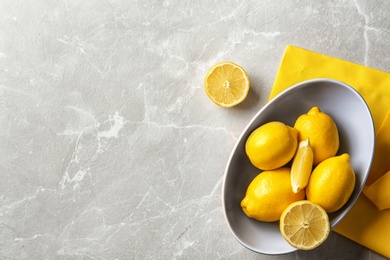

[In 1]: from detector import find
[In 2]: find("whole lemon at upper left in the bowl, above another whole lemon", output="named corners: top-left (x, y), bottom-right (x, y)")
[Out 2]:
top-left (245, 121), bottom-right (298, 170)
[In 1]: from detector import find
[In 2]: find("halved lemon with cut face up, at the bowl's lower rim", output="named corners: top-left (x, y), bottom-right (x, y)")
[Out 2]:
top-left (279, 200), bottom-right (330, 250)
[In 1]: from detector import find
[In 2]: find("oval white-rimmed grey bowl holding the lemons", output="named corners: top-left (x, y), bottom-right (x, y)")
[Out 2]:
top-left (222, 79), bottom-right (375, 254)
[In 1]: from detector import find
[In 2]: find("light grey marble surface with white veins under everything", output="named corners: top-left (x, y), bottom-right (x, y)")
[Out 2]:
top-left (0, 0), bottom-right (390, 259)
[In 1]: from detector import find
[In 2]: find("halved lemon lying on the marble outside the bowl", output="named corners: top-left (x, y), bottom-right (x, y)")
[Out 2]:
top-left (204, 62), bottom-right (250, 107)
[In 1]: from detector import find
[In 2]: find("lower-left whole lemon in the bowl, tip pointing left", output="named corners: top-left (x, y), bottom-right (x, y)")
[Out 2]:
top-left (241, 167), bottom-right (305, 222)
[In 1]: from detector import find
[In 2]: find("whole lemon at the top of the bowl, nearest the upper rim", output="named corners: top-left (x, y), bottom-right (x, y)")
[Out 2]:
top-left (294, 106), bottom-right (339, 165)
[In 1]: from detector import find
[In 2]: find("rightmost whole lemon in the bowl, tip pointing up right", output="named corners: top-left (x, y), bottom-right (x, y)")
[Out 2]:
top-left (306, 153), bottom-right (356, 213)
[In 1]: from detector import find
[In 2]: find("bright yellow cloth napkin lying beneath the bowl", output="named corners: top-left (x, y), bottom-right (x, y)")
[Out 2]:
top-left (270, 46), bottom-right (390, 258)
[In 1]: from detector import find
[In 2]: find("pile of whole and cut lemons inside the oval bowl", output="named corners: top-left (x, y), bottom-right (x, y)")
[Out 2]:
top-left (241, 106), bottom-right (355, 250)
